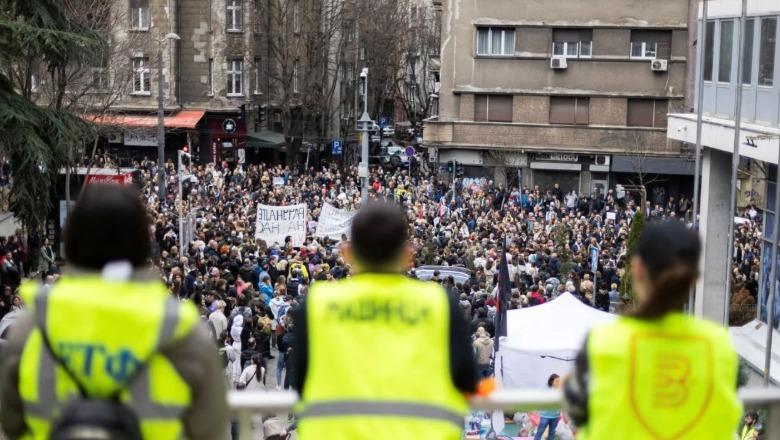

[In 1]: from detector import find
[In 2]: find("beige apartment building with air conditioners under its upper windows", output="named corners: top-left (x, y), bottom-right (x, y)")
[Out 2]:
top-left (424, 0), bottom-right (692, 199)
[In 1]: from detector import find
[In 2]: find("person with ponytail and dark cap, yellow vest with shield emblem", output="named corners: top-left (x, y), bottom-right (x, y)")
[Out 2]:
top-left (564, 221), bottom-right (742, 440)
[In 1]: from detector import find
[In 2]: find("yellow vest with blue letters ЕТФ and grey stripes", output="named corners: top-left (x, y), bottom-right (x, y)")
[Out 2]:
top-left (19, 276), bottom-right (198, 440)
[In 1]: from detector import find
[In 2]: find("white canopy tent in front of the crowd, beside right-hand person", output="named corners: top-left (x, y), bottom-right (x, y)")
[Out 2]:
top-left (496, 293), bottom-right (616, 388)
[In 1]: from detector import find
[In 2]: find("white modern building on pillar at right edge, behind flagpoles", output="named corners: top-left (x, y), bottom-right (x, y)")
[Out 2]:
top-left (667, 0), bottom-right (780, 336)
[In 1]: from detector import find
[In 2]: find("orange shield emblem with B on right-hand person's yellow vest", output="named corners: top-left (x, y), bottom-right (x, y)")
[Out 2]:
top-left (629, 334), bottom-right (714, 440)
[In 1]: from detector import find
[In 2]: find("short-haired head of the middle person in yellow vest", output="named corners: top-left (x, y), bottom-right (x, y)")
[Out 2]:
top-left (347, 202), bottom-right (411, 272)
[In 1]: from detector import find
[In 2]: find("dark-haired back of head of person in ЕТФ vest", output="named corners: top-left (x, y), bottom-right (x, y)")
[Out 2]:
top-left (64, 184), bottom-right (151, 270)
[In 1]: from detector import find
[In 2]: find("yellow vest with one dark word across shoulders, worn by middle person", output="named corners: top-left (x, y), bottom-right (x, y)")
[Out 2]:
top-left (297, 274), bottom-right (468, 440)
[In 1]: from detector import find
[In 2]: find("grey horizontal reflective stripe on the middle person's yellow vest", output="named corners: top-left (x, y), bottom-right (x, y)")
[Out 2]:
top-left (298, 401), bottom-right (463, 429)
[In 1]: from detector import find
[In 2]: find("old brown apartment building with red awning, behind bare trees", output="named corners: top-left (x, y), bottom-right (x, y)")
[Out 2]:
top-left (90, 0), bottom-right (352, 163)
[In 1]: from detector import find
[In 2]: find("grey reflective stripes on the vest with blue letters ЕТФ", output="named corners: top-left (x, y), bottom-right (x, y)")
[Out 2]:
top-left (23, 288), bottom-right (186, 421)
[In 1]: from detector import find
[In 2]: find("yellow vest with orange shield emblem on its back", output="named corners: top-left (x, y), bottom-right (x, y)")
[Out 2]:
top-left (579, 313), bottom-right (742, 440)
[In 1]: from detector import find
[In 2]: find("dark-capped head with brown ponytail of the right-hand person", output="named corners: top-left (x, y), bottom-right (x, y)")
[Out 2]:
top-left (633, 220), bottom-right (701, 319)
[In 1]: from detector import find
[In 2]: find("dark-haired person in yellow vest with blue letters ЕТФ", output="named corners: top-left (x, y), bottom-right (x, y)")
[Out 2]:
top-left (0, 185), bottom-right (228, 440)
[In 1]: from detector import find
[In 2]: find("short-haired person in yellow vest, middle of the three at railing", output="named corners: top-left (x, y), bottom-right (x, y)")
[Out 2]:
top-left (292, 203), bottom-right (477, 440)
